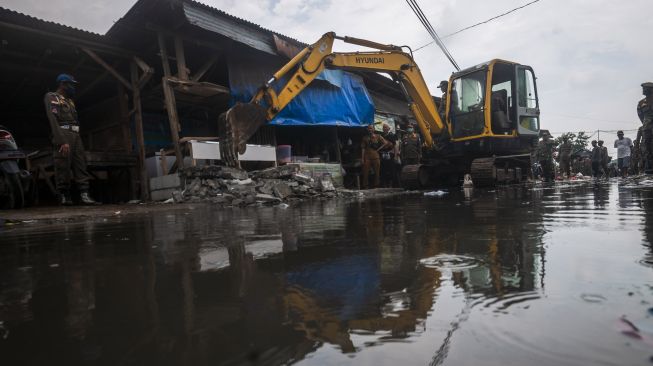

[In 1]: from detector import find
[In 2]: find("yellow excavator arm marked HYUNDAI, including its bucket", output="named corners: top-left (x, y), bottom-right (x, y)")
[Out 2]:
top-left (219, 32), bottom-right (446, 165)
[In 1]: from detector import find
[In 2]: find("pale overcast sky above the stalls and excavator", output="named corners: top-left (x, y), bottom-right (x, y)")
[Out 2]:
top-left (0, 0), bottom-right (653, 149)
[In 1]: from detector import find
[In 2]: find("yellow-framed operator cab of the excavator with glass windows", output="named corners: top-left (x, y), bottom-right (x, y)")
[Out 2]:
top-left (446, 60), bottom-right (540, 142)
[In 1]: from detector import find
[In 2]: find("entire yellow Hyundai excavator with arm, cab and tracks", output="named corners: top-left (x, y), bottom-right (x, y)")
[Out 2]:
top-left (218, 32), bottom-right (539, 188)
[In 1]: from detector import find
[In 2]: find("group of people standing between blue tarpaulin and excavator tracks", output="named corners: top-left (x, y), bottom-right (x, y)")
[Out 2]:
top-left (361, 124), bottom-right (422, 189)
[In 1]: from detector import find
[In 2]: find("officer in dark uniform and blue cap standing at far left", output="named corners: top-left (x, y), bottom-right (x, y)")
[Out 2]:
top-left (44, 74), bottom-right (97, 205)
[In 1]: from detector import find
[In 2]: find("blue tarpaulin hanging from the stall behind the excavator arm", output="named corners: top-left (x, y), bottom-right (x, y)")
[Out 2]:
top-left (229, 50), bottom-right (374, 127)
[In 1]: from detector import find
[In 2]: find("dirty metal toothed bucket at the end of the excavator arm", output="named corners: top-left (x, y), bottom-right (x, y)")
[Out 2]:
top-left (218, 103), bottom-right (267, 166)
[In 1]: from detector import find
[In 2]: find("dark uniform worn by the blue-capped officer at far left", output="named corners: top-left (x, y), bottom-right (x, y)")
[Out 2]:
top-left (44, 92), bottom-right (90, 192)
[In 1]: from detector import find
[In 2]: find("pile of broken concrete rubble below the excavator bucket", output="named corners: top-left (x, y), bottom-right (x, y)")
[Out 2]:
top-left (172, 165), bottom-right (338, 206)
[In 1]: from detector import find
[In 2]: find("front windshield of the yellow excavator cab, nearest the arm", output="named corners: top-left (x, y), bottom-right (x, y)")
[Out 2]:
top-left (449, 70), bottom-right (486, 138)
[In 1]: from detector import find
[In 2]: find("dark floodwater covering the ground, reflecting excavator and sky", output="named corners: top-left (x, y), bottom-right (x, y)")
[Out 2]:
top-left (0, 179), bottom-right (653, 365)
